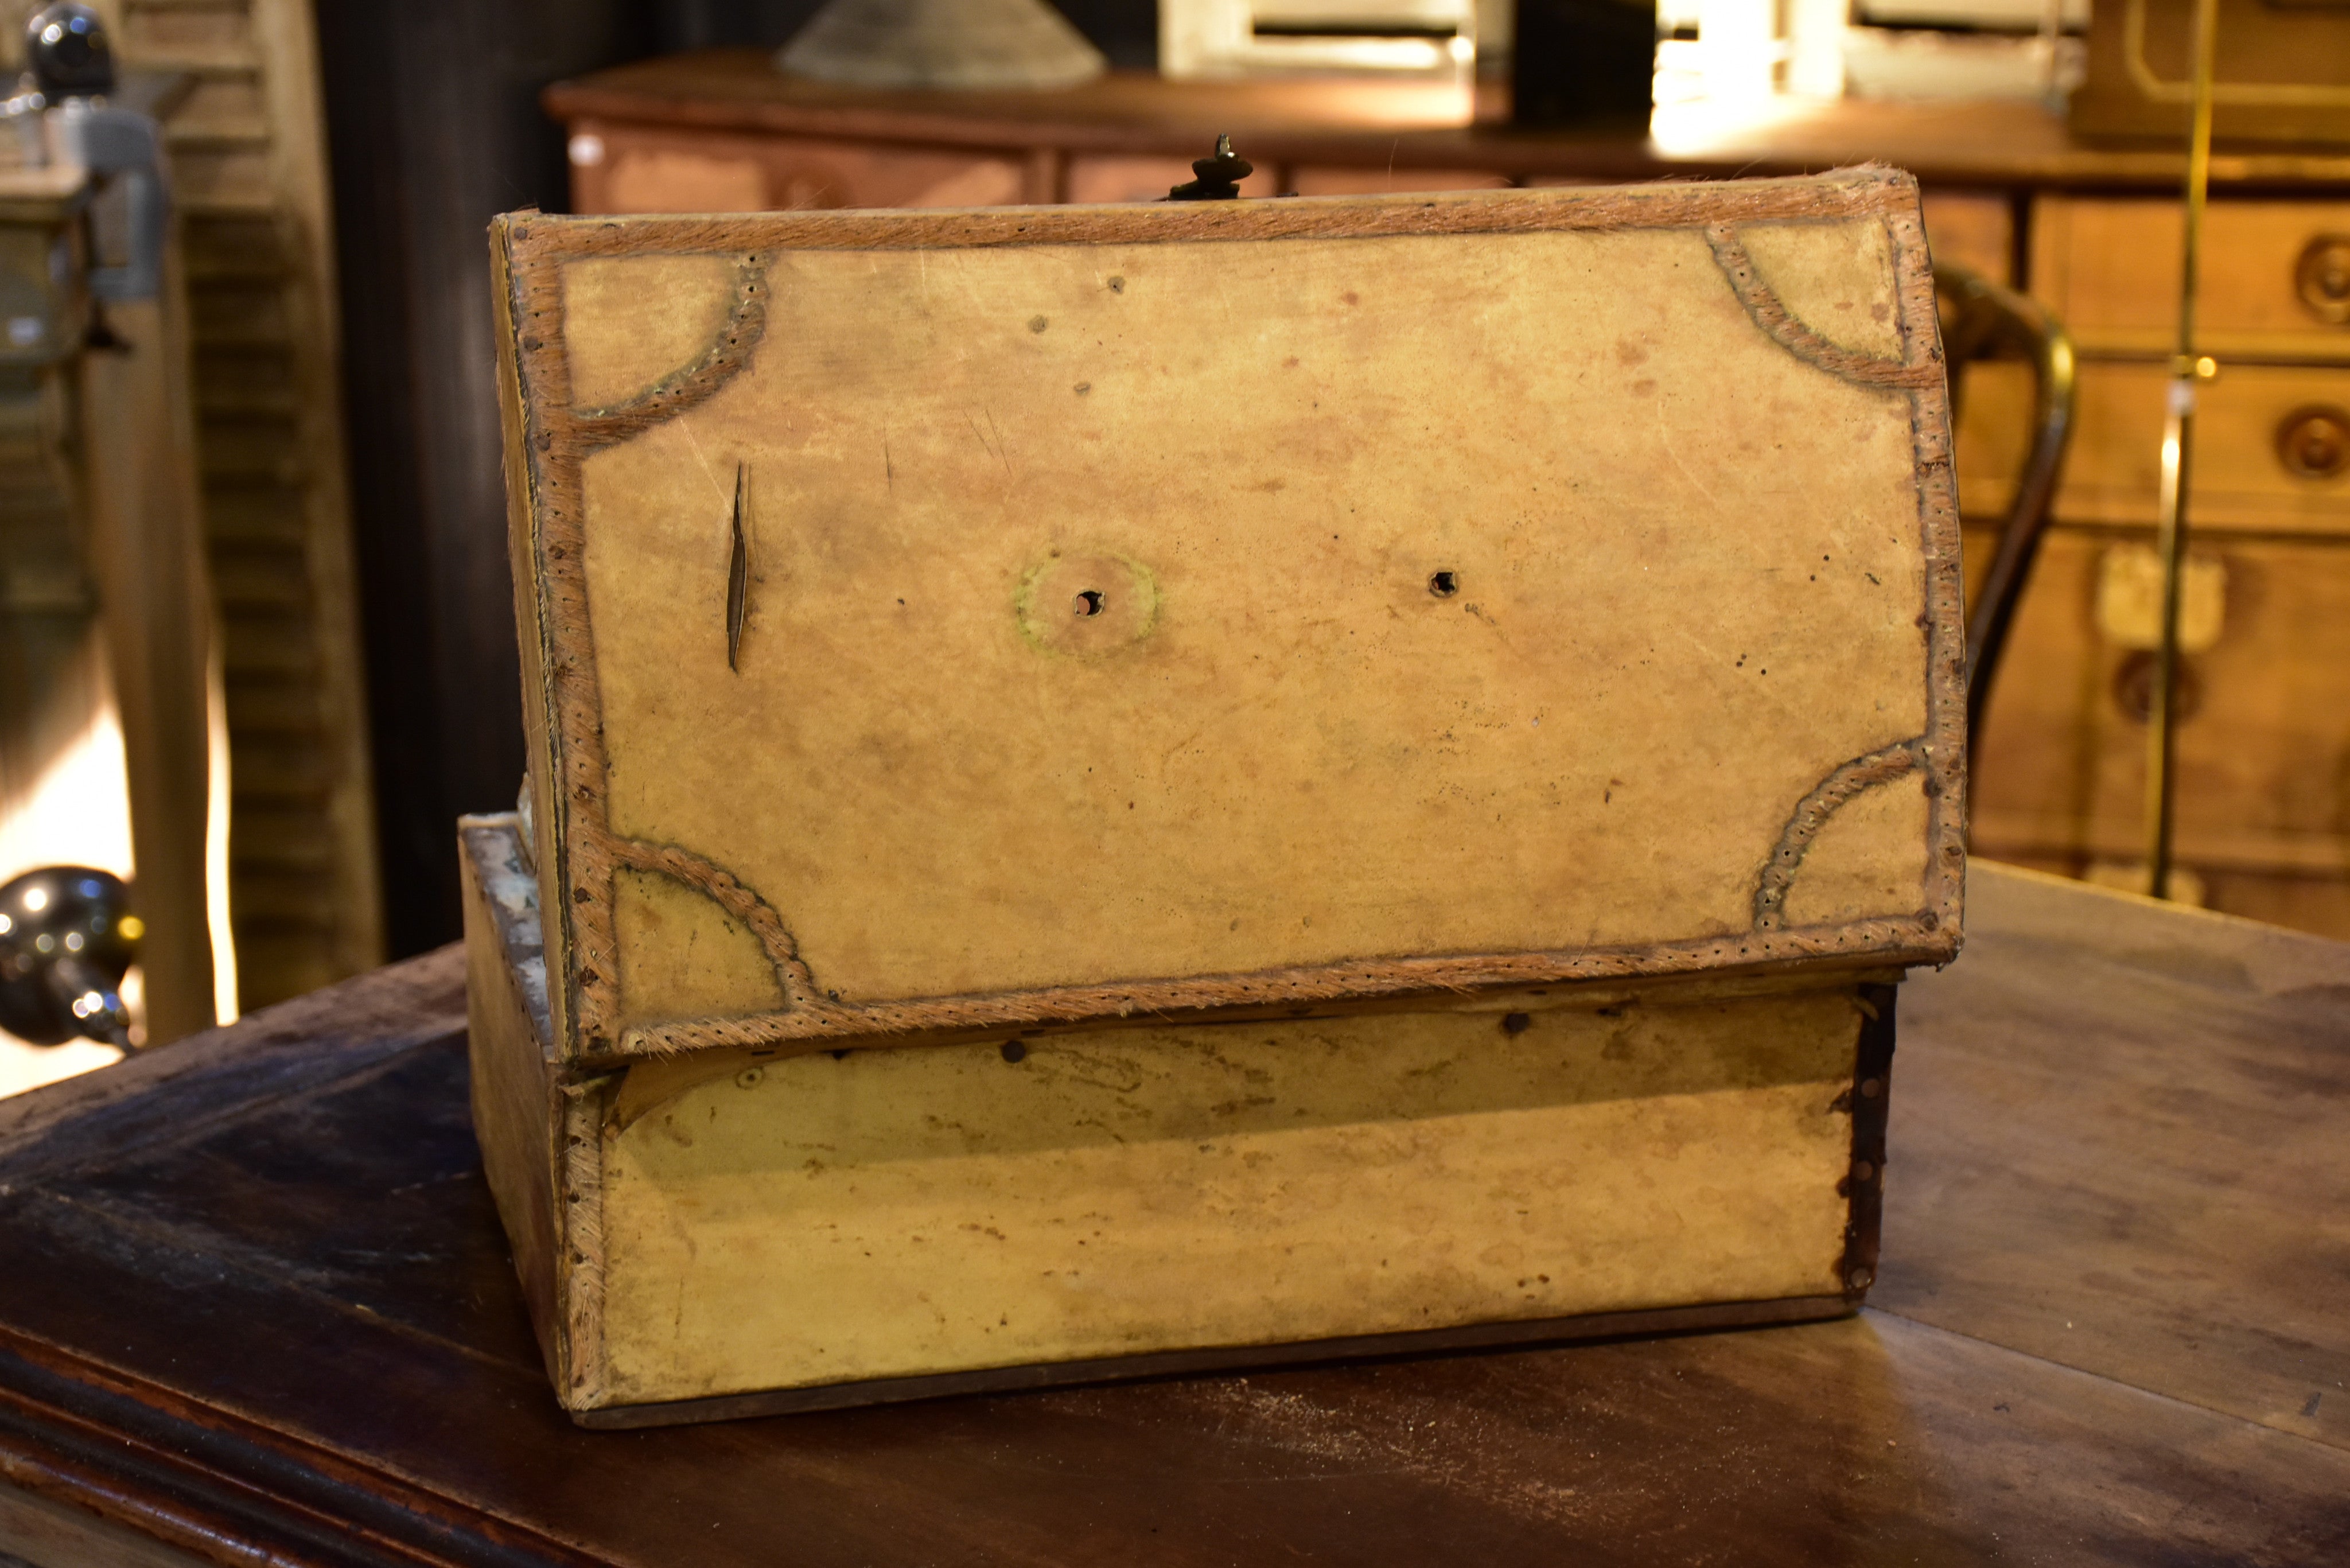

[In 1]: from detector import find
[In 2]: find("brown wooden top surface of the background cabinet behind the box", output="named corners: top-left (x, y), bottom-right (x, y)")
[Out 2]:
top-left (545, 49), bottom-right (2350, 195)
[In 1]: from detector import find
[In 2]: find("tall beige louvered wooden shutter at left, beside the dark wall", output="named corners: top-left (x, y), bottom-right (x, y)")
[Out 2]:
top-left (0, 0), bottom-right (383, 1037)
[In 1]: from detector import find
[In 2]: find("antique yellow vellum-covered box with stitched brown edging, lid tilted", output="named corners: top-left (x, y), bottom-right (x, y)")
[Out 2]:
top-left (461, 172), bottom-right (1962, 1425)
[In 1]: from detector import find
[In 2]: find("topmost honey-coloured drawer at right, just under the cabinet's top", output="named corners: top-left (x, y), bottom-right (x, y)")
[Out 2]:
top-left (2030, 195), bottom-right (2350, 353)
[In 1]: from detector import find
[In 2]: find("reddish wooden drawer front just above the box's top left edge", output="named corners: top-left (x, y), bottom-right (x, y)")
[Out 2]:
top-left (569, 120), bottom-right (1025, 212)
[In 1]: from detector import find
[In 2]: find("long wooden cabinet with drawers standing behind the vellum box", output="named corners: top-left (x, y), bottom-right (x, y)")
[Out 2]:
top-left (547, 52), bottom-right (2350, 936)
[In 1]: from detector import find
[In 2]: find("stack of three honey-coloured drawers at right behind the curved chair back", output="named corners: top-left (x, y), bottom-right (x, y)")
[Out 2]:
top-left (1960, 195), bottom-right (2350, 936)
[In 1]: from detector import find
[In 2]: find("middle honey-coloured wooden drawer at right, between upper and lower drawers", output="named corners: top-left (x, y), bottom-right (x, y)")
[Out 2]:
top-left (1958, 362), bottom-right (2350, 534)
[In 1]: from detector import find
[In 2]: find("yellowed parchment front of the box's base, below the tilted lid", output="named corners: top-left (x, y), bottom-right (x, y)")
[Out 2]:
top-left (599, 990), bottom-right (1859, 1403)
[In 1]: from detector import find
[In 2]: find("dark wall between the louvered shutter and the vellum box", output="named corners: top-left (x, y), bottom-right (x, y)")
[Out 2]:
top-left (317, 0), bottom-right (1156, 957)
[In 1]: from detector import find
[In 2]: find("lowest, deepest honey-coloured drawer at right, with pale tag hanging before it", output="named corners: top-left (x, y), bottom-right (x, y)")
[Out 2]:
top-left (1967, 529), bottom-right (2350, 933)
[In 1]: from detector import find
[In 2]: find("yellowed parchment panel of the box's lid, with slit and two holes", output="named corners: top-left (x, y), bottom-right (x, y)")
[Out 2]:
top-left (566, 219), bottom-right (1927, 1020)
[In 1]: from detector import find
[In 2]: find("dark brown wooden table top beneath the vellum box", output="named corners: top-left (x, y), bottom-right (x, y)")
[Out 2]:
top-left (0, 865), bottom-right (2350, 1568)
